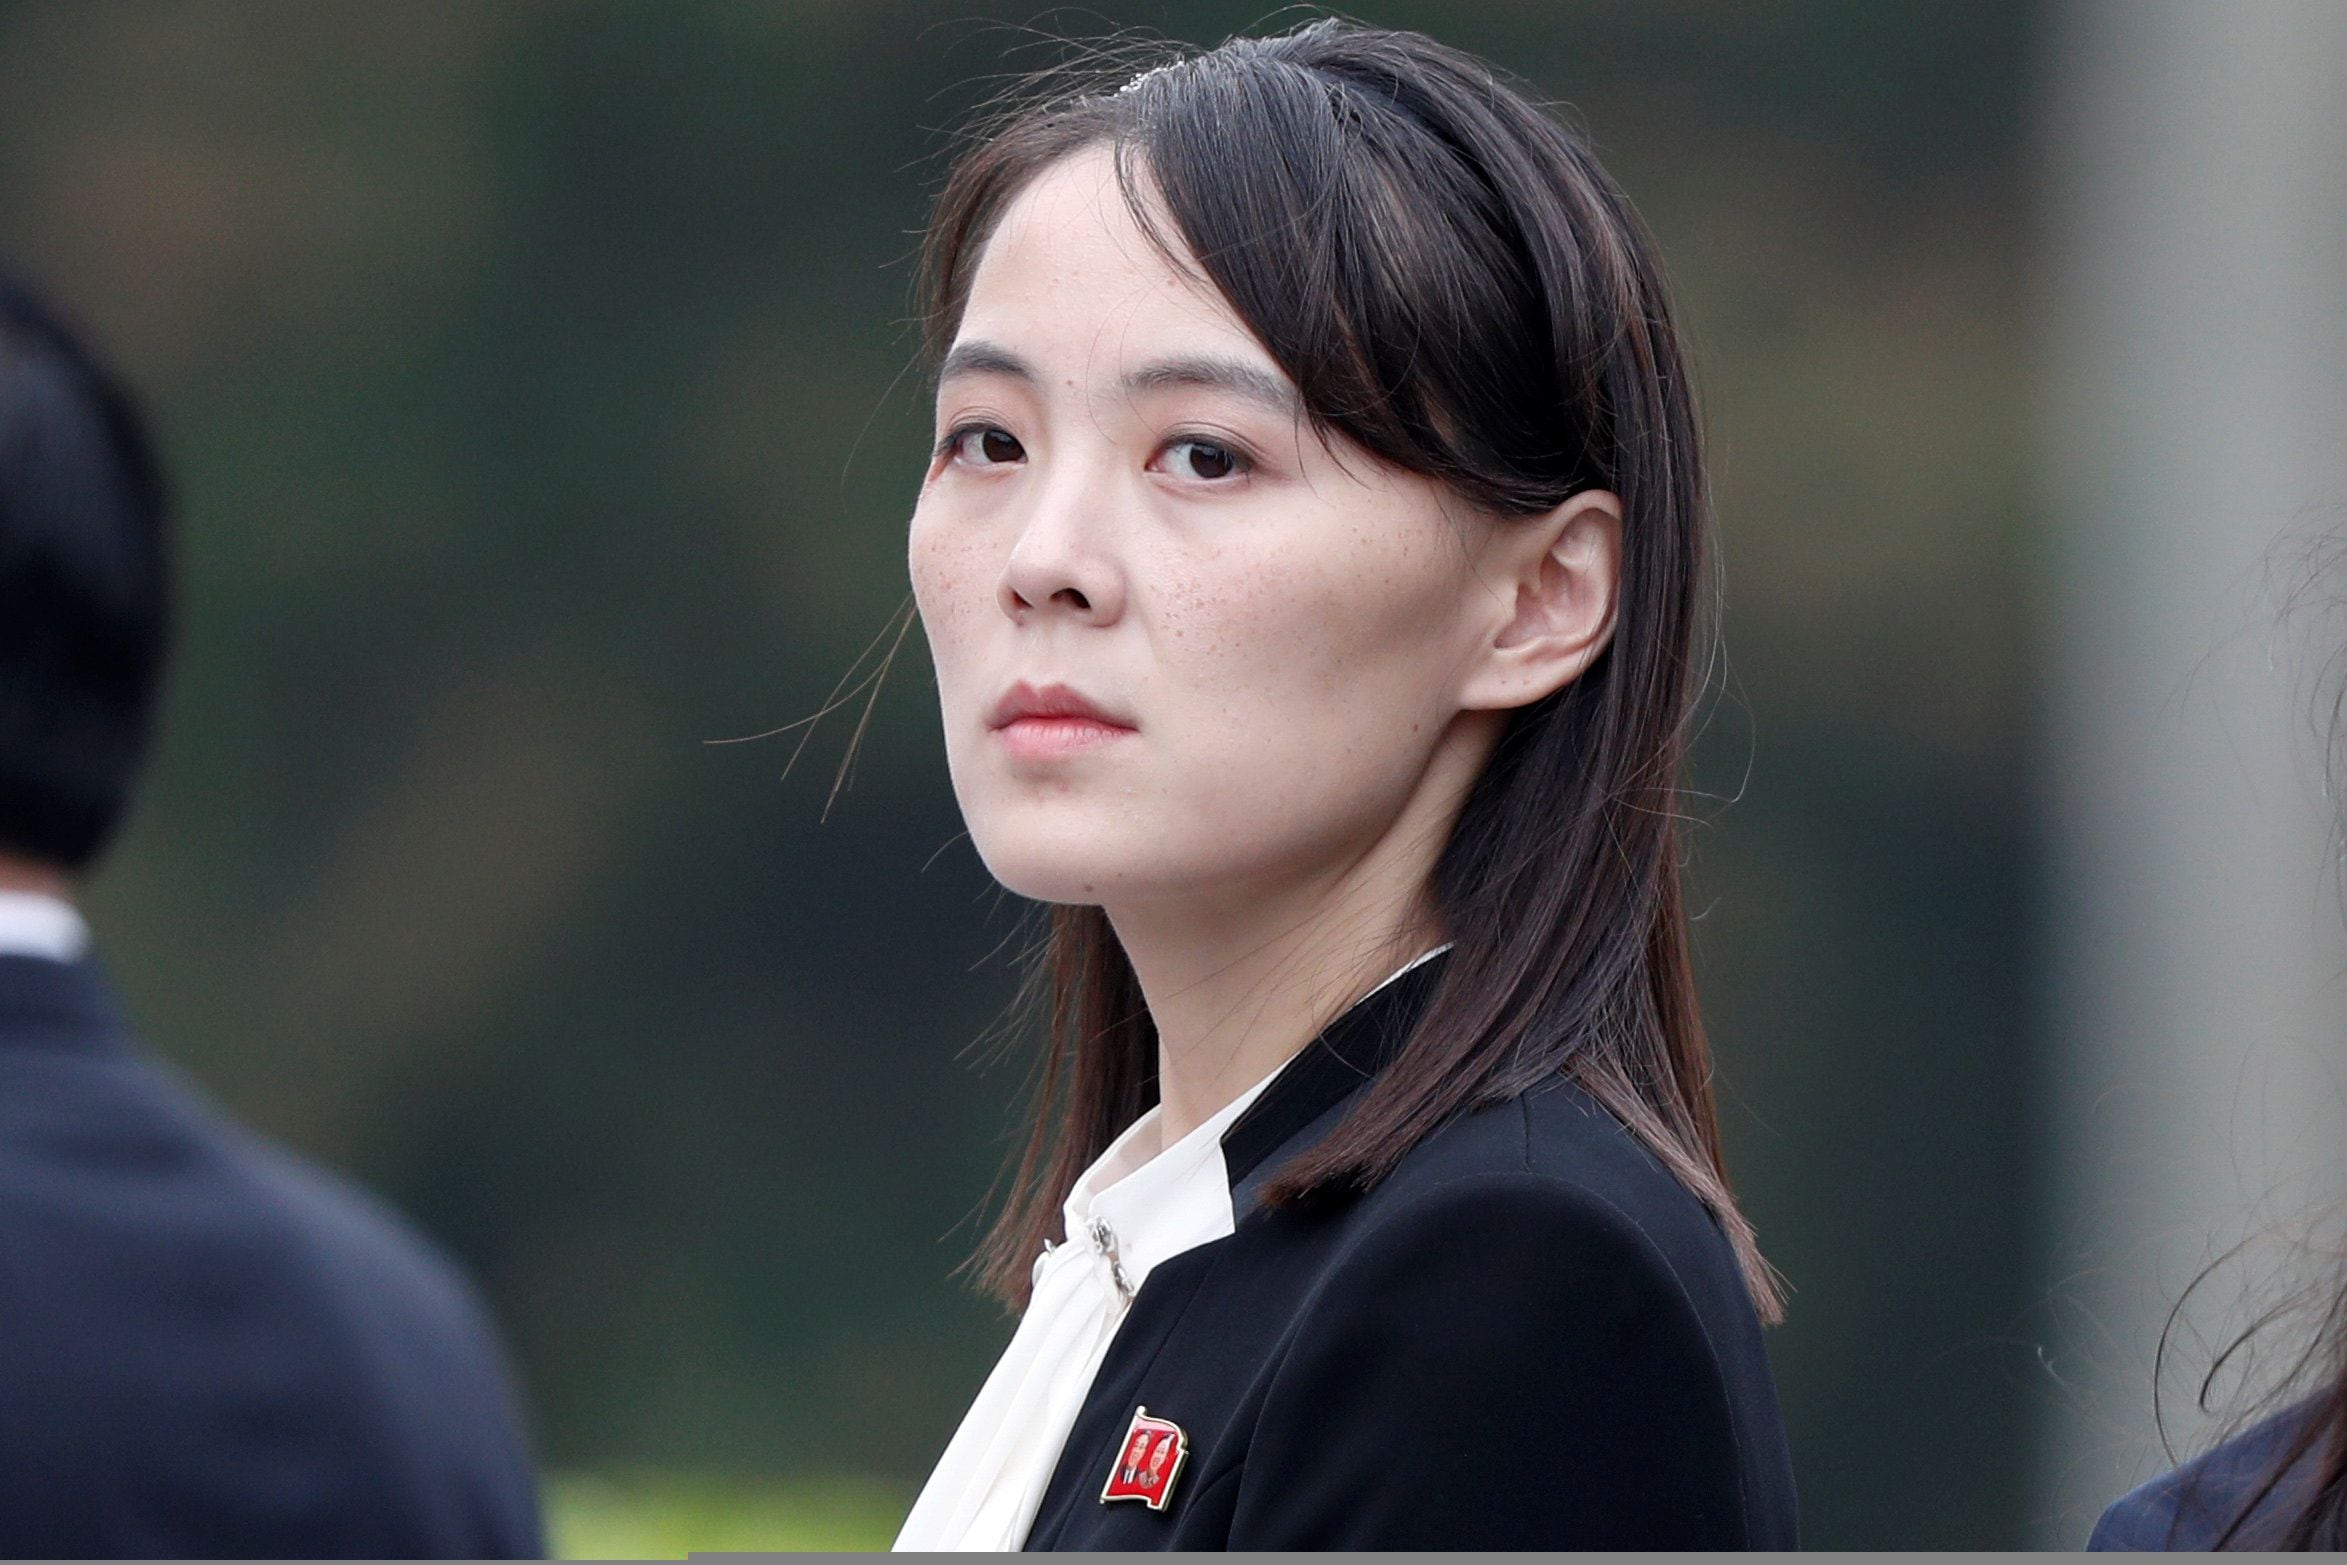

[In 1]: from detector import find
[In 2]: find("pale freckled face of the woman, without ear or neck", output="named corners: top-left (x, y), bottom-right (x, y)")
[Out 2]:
top-left (911, 148), bottom-right (1504, 910)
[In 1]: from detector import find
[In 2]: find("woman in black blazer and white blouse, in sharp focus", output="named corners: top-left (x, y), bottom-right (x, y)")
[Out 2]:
top-left (897, 21), bottom-right (1793, 1549)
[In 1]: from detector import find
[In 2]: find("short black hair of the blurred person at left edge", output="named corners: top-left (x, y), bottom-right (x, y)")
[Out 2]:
top-left (0, 270), bottom-right (171, 870)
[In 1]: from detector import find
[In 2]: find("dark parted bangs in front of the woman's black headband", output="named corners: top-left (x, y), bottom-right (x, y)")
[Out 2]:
top-left (922, 23), bottom-right (1605, 514)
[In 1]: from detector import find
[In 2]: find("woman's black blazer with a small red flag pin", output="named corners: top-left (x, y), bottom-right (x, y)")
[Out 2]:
top-left (1028, 962), bottom-right (1793, 1549)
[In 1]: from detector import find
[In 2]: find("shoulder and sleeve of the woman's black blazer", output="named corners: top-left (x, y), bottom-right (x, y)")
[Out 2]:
top-left (1204, 1084), bottom-right (1793, 1549)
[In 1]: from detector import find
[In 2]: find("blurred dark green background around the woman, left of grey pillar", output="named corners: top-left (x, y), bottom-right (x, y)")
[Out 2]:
top-left (0, 0), bottom-right (2054, 1556)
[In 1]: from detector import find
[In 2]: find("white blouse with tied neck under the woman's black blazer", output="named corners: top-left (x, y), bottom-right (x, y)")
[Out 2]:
top-left (897, 946), bottom-right (1448, 1551)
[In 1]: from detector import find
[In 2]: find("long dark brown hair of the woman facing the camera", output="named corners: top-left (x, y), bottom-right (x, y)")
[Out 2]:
top-left (922, 21), bottom-right (1779, 1319)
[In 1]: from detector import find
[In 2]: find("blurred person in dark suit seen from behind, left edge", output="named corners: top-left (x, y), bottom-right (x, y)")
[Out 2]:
top-left (0, 262), bottom-right (545, 1558)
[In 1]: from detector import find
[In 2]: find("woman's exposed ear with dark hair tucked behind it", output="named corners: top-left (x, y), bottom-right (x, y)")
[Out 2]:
top-left (1460, 488), bottom-right (1622, 711)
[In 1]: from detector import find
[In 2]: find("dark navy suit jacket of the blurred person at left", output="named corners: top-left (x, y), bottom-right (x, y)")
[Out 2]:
top-left (0, 957), bottom-right (542, 1558)
